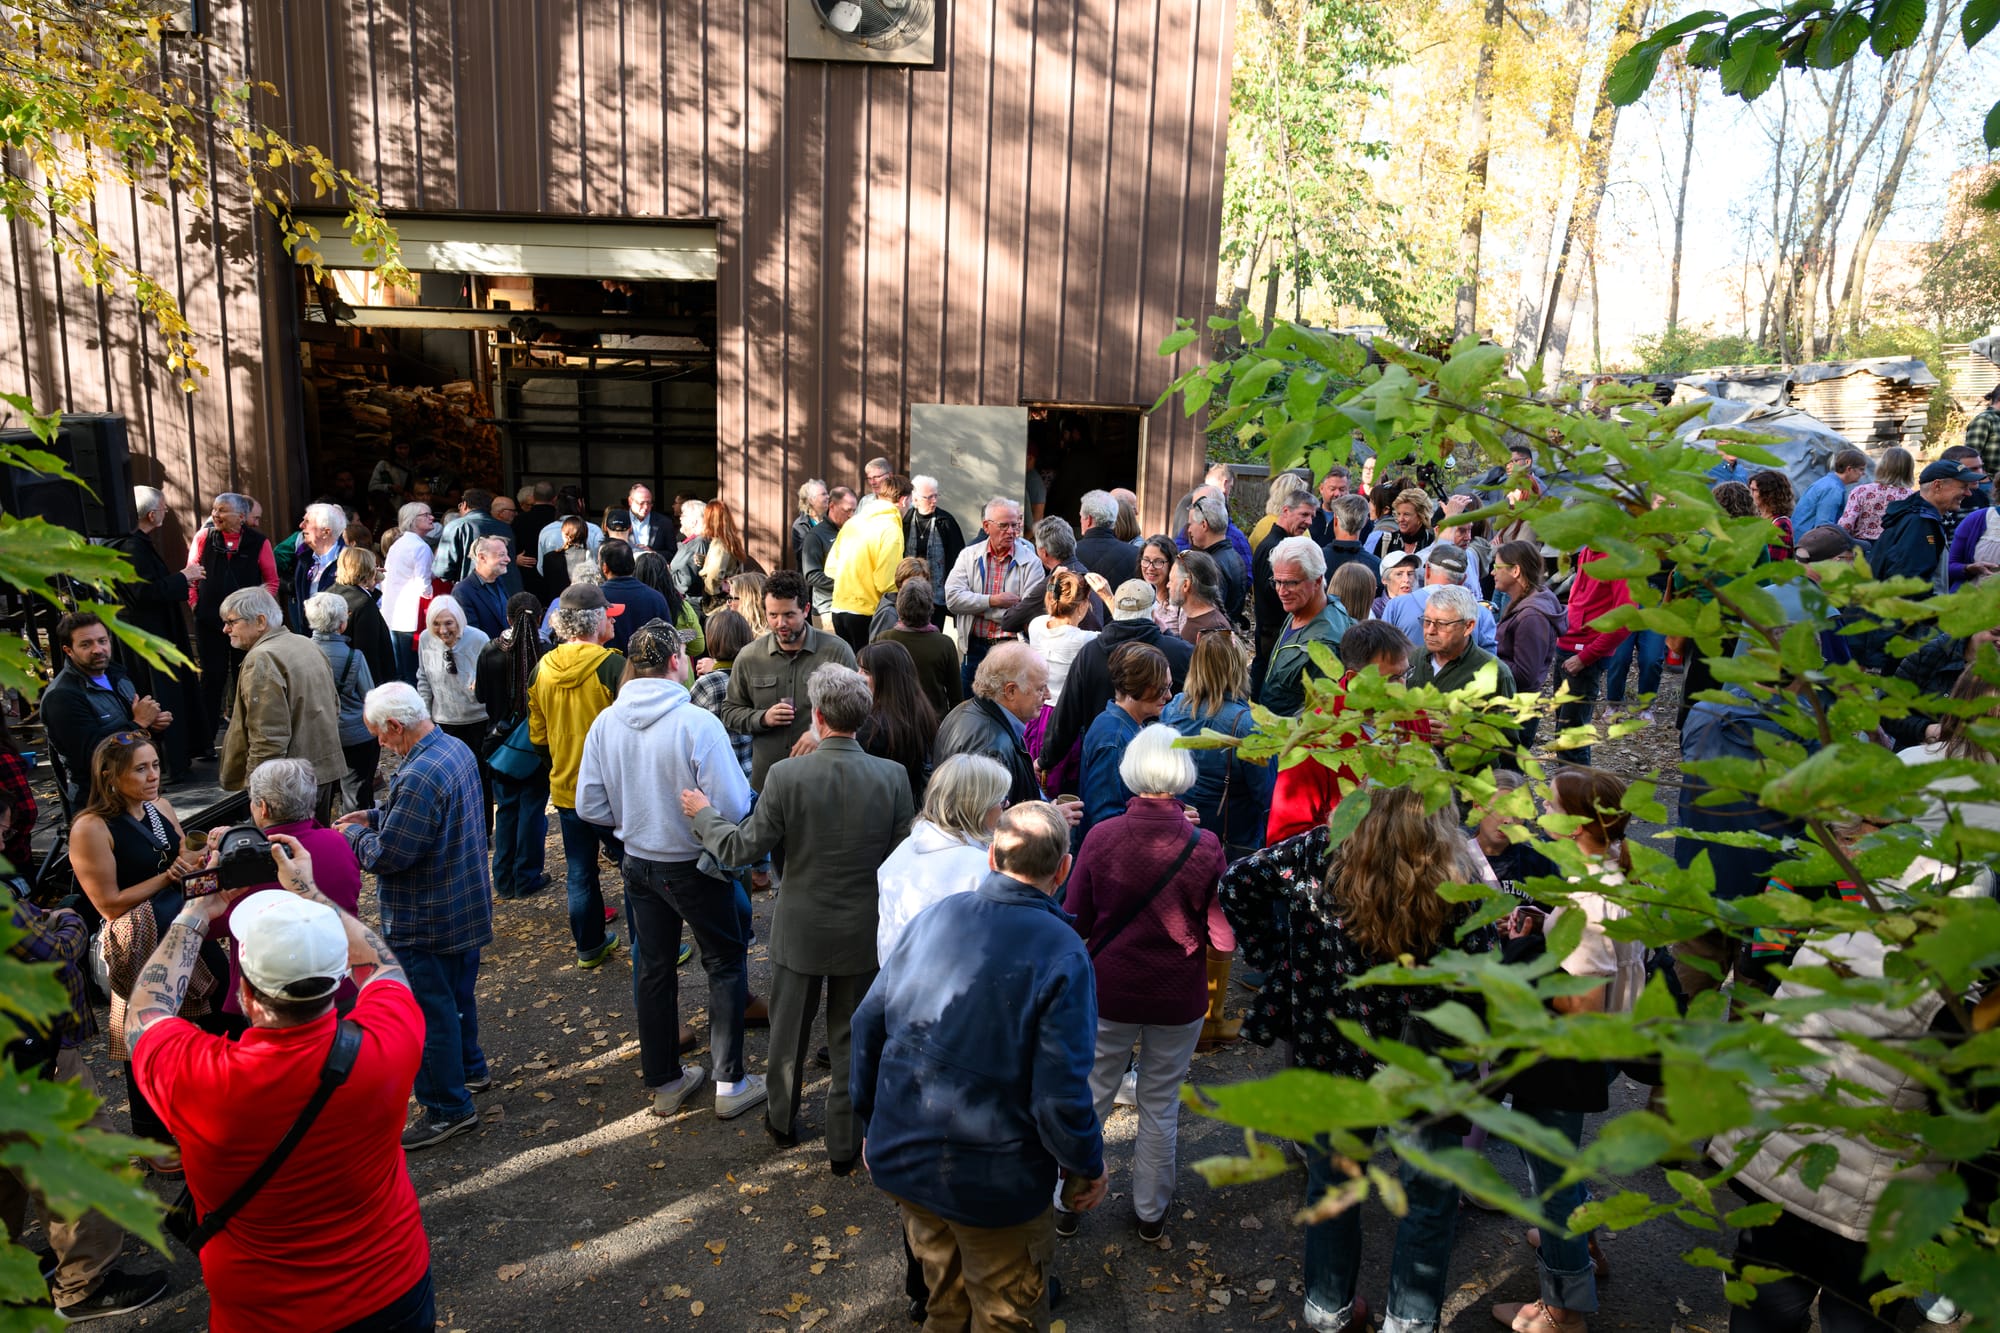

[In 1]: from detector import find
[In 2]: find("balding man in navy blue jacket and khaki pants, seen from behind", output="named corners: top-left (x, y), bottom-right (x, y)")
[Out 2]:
top-left (852, 801), bottom-right (1104, 1329)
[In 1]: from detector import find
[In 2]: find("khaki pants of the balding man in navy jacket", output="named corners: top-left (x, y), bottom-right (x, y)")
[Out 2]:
top-left (896, 1199), bottom-right (1056, 1333)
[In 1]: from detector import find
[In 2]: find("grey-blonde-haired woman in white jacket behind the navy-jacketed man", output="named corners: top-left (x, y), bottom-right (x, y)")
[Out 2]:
top-left (876, 755), bottom-right (1012, 965)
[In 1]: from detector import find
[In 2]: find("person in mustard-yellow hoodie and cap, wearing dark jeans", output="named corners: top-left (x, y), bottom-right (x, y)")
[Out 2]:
top-left (528, 582), bottom-right (624, 971)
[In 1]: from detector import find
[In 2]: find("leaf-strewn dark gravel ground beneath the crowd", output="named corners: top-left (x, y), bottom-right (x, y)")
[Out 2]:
top-left (54, 660), bottom-right (1816, 1333)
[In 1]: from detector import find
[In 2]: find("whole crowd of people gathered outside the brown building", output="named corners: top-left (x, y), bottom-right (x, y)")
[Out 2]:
top-left (0, 410), bottom-right (2000, 1333)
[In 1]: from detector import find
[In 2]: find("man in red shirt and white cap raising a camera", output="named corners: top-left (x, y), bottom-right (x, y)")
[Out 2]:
top-left (126, 835), bottom-right (436, 1333)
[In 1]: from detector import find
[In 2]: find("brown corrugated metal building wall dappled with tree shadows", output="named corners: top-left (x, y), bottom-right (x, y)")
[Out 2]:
top-left (0, 0), bottom-right (1234, 558)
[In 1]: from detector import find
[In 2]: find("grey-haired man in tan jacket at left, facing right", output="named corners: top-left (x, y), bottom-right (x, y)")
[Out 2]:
top-left (222, 588), bottom-right (348, 825)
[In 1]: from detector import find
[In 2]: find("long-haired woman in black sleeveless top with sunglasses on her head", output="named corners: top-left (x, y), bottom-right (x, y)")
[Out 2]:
top-left (70, 731), bottom-right (228, 1175)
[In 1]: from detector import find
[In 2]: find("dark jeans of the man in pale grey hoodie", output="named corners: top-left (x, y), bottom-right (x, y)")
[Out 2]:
top-left (624, 857), bottom-right (750, 1087)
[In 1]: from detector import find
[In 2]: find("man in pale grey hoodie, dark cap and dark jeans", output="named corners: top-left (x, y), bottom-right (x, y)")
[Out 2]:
top-left (576, 620), bottom-right (766, 1119)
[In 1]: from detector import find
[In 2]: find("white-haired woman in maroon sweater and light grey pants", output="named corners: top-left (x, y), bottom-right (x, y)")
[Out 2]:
top-left (1056, 723), bottom-right (1236, 1241)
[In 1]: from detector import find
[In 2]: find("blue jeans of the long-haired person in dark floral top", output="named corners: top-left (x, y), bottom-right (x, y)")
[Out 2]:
top-left (1306, 1127), bottom-right (1460, 1333)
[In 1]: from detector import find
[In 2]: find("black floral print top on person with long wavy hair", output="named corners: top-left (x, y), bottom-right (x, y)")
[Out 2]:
top-left (1220, 827), bottom-right (1498, 1079)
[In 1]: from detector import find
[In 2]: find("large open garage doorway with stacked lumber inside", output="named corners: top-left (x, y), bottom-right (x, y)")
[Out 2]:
top-left (300, 218), bottom-right (718, 524)
